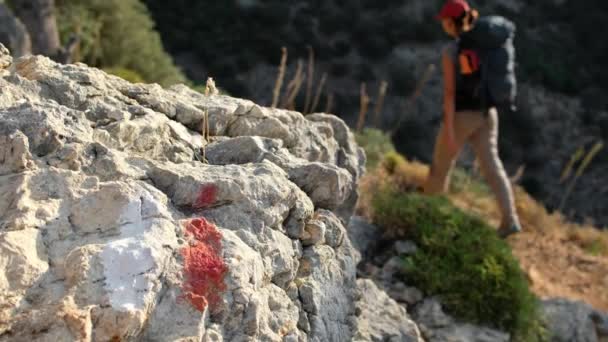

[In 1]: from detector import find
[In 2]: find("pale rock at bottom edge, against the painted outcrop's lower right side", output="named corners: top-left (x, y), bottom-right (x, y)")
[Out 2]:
top-left (352, 279), bottom-right (422, 342)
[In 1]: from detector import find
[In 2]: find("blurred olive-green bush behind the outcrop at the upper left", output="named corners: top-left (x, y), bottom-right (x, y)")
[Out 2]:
top-left (56, 0), bottom-right (185, 85)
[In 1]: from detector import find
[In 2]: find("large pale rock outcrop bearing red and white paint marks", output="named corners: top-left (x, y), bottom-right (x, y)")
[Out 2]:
top-left (0, 50), bottom-right (426, 341)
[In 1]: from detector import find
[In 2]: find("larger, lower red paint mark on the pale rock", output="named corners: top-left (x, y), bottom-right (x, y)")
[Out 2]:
top-left (181, 218), bottom-right (228, 311)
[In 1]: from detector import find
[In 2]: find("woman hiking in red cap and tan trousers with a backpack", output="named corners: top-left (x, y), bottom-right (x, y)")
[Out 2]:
top-left (424, 0), bottom-right (521, 238)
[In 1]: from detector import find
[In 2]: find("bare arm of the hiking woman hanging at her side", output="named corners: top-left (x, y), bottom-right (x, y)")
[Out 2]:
top-left (441, 49), bottom-right (456, 153)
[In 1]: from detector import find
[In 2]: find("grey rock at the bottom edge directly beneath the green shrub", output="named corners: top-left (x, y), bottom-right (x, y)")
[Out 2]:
top-left (413, 298), bottom-right (510, 342)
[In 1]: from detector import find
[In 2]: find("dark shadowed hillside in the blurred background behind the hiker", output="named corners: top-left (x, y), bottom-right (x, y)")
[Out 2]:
top-left (146, 0), bottom-right (608, 227)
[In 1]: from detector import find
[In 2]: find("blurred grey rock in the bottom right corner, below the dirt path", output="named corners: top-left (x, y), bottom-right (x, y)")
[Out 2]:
top-left (542, 299), bottom-right (608, 342)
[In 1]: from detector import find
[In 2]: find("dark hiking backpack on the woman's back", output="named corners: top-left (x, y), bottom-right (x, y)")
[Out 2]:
top-left (460, 16), bottom-right (517, 109)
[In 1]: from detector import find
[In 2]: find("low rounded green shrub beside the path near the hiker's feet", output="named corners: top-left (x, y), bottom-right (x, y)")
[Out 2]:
top-left (372, 189), bottom-right (544, 341)
